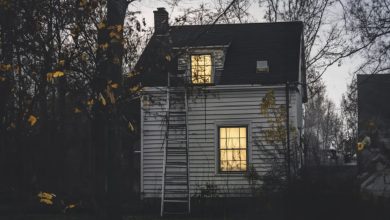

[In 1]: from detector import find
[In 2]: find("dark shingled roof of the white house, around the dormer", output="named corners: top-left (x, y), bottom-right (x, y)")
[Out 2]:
top-left (135, 22), bottom-right (306, 99)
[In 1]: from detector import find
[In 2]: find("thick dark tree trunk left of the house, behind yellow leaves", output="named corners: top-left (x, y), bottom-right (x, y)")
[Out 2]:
top-left (93, 0), bottom-right (129, 219)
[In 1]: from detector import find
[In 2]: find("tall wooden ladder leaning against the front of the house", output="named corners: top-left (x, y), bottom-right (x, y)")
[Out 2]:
top-left (160, 74), bottom-right (191, 216)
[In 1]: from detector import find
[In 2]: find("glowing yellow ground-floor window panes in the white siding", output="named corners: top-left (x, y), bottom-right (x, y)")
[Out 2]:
top-left (219, 127), bottom-right (248, 171)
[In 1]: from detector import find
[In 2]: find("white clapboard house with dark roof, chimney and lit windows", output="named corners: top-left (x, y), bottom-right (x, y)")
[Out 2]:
top-left (136, 8), bottom-right (306, 214)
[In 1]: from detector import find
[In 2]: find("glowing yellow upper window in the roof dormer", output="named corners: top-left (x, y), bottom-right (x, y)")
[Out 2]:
top-left (191, 55), bottom-right (212, 84)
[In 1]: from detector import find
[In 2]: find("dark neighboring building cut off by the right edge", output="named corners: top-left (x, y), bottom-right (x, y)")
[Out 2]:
top-left (357, 74), bottom-right (390, 197)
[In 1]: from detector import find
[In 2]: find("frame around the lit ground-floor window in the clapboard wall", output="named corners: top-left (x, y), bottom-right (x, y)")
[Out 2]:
top-left (216, 124), bottom-right (250, 174)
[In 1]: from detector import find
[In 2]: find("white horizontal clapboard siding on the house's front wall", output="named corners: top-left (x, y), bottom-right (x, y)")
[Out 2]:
top-left (141, 85), bottom-right (302, 197)
